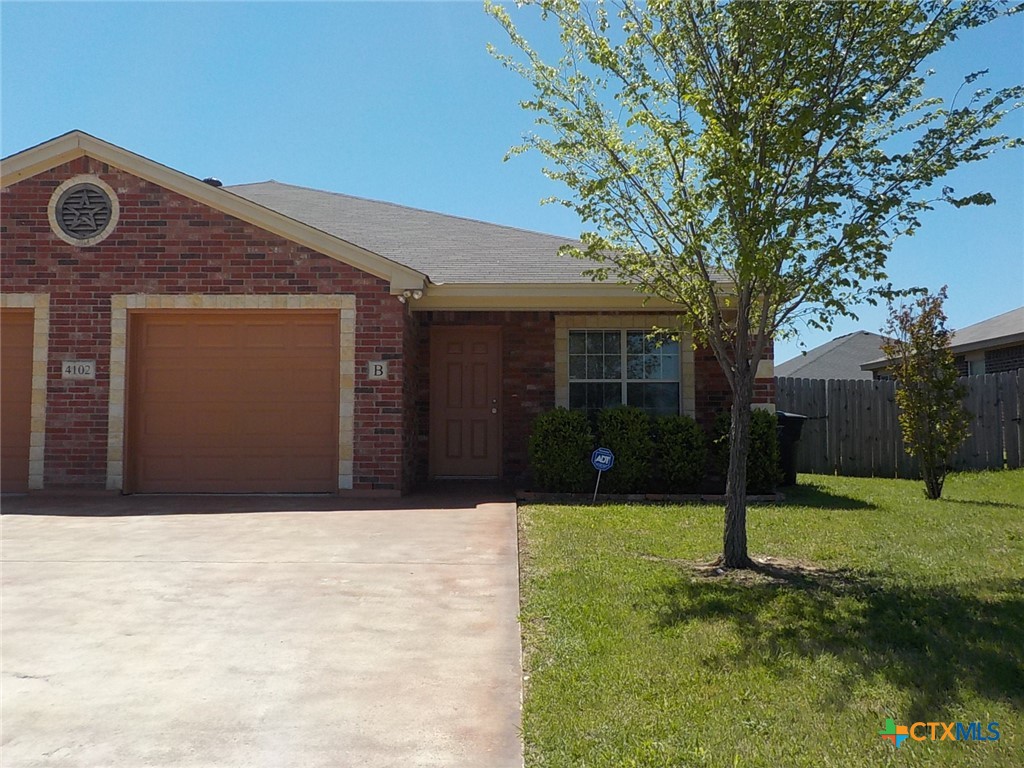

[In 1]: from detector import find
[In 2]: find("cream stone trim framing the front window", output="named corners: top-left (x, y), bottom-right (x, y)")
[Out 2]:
top-left (555, 314), bottom-right (696, 418)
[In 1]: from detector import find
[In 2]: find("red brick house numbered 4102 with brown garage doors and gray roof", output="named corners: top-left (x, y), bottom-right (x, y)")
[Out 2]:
top-left (0, 131), bottom-right (774, 496)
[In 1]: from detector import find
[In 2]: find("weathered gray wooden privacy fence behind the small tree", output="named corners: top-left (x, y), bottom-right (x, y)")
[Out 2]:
top-left (775, 370), bottom-right (1024, 478)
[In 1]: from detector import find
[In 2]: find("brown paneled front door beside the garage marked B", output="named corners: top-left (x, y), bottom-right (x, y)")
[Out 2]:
top-left (430, 326), bottom-right (501, 477)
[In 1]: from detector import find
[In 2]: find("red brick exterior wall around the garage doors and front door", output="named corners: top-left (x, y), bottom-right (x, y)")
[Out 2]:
top-left (0, 158), bottom-right (774, 493)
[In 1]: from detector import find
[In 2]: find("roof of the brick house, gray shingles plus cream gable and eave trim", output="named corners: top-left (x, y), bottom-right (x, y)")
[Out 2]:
top-left (0, 131), bottom-right (688, 311)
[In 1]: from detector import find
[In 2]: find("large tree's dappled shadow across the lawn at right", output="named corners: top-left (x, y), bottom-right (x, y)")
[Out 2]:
top-left (655, 564), bottom-right (1024, 721)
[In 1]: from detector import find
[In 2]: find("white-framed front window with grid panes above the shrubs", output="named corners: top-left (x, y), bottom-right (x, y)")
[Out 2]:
top-left (569, 331), bottom-right (679, 416)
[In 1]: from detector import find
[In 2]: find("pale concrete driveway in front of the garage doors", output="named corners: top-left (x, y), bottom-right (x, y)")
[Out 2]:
top-left (0, 497), bottom-right (522, 768)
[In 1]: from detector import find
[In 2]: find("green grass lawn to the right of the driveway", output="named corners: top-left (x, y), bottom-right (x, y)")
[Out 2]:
top-left (520, 471), bottom-right (1024, 768)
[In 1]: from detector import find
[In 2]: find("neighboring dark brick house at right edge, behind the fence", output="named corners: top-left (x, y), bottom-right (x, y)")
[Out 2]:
top-left (861, 306), bottom-right (1024, 379)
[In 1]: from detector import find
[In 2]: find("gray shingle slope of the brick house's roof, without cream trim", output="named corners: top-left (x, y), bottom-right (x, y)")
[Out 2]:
top-left (224, 181), bottom-right (591, 284)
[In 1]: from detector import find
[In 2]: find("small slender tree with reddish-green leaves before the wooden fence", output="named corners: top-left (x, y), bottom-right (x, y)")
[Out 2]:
top-left (882, 286), bottom-right (968, 499)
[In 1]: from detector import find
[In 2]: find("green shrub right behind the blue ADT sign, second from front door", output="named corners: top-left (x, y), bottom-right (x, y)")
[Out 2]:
top-left (597, 406), bottom-right (654, 494)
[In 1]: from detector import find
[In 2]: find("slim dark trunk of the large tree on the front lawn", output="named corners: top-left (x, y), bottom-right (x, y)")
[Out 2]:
top-left (722, 372), bottom-right (754, 568)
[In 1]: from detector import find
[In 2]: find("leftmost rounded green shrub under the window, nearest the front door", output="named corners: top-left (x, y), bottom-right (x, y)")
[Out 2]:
top-left (528, 408), bottom-right (594, 494)
